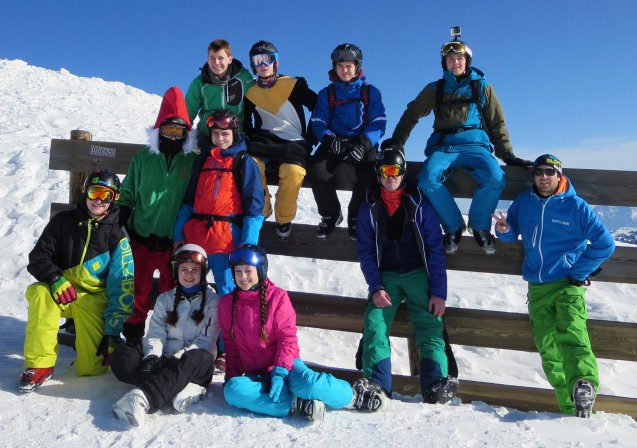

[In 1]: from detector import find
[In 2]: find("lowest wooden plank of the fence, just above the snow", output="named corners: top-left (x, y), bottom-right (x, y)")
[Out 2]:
top-left (307, 362), bottom-right (637, 419)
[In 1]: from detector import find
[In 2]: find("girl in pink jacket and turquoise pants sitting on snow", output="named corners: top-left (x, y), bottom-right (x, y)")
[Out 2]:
top-left (219, 245), bottom-right (376, 420)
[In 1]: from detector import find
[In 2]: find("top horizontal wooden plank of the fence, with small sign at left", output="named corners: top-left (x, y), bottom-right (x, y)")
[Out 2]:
top-left (49, 139), bottom-right (637, 207)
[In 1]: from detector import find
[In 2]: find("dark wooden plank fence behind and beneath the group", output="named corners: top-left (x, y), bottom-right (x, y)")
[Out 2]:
top-left (49, 131), bottom-right (637, 418)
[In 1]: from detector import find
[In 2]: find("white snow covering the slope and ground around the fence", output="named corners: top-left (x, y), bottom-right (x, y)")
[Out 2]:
top-left (0, 60), bottom-right (637, 447)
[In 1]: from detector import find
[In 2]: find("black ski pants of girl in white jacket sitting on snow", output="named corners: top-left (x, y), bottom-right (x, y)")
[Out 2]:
top-left (111, 345), bottom-right (214, 411)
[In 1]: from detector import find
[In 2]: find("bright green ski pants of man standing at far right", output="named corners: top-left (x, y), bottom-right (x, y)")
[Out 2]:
top-left (528, 280), bottom-right (599, 414)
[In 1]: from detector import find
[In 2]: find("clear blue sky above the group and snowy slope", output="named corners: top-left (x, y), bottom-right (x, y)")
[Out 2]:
top-left (0, 0), bottom-right (637, 170)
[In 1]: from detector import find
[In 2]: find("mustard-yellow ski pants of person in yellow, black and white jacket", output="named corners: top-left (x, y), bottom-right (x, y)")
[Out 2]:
top-left (254, 157), bottom-right (305, 228)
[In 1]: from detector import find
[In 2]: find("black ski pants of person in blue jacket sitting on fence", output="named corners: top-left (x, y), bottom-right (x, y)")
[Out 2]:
top-left (312, 148), bottom-right (376, 229)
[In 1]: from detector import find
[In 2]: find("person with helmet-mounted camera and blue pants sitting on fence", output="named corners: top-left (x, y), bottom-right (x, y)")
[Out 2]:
top-left (382, 27), bottom-right (531, 255)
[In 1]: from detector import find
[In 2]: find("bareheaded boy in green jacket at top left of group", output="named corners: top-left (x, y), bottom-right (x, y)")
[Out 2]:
top-left (186, 39), bottom-right (254, 151)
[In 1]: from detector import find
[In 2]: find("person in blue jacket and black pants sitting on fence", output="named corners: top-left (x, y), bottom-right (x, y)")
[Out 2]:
top-left (310, 44), bottom-right (387, 239)
